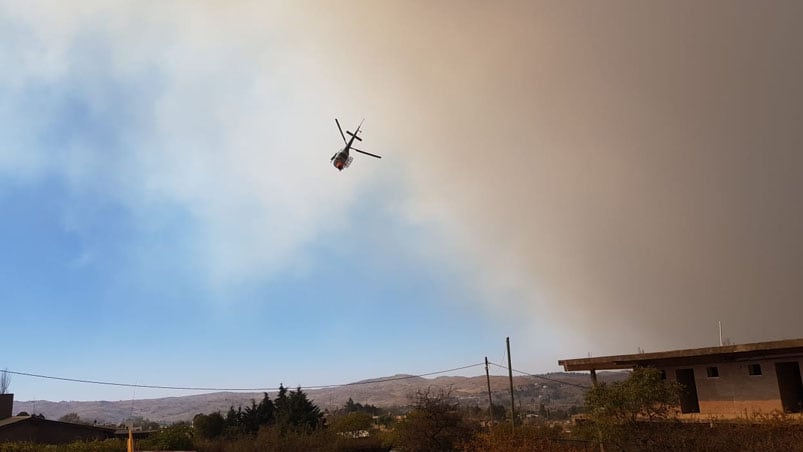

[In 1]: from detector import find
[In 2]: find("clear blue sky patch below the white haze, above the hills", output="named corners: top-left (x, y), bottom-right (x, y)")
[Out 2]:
top-left (0, 132), bottom-right (516, 399)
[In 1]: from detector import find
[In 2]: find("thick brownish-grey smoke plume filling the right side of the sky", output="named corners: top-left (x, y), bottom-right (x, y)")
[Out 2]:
top-left (296, 1), bottom-right (803, 357)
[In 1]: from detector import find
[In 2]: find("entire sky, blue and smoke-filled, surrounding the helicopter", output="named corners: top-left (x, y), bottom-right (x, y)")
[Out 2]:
top-left (0, 1), bottom-right (803, 400)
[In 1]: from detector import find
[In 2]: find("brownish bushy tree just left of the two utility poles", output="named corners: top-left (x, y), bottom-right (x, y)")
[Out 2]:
top-left (396, 389), bottom-right (478, 452)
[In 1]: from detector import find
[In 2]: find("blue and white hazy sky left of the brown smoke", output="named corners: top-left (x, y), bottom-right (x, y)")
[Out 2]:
top-left (0, 4), bottom-right (548, 400)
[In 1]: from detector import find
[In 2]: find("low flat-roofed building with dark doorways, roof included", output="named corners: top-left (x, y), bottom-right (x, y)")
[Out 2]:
top-left (558, 339), bottom-right (803, 418)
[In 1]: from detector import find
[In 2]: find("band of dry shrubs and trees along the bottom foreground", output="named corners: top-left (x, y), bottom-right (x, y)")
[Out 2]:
top-left (6, 369), bottom-right (803, 452)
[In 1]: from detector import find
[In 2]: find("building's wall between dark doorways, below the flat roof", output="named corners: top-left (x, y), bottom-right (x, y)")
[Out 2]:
top-left (662, 357), bottom-right (803, 418)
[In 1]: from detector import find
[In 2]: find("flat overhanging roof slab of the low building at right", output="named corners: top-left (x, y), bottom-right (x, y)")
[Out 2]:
top-left (558, 339), bottom-right (803, 372)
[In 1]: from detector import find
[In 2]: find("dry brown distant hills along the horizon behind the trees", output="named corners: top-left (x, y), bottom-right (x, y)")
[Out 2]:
top-left (14, 372), bottom-right (627, 424)
